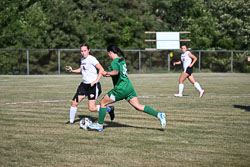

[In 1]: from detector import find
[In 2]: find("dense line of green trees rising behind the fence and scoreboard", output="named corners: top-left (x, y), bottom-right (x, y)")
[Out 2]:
top-left (0, 0), bottom-right (250, 73)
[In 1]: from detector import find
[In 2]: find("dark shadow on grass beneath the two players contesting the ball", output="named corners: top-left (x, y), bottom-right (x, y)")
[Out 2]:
top-left (75, 115), bottom-right (164, 131)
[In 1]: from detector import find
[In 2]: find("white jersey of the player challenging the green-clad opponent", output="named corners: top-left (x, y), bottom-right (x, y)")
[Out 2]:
top-left (80, 55), bottom-right (99, 84)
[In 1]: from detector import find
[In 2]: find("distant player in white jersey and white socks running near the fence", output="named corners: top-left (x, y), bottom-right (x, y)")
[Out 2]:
top-left (173, 45), bottom-right (205, 97)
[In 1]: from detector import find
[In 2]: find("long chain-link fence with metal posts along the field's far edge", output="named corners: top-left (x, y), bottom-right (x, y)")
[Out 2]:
top-left (0, 48), bottom-right (250, 75)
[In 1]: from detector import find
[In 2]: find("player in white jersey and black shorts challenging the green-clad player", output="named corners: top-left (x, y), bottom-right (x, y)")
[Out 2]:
top-left (66, 44), bottom-right (115, 124)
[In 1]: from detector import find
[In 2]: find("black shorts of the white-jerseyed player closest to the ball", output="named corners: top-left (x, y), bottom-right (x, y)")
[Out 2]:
top-left (72, 82), bottom-right (102, 103)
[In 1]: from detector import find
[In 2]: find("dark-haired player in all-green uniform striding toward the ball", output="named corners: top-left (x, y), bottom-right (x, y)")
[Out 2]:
top-left (89, 45), bottom-right (166, 131)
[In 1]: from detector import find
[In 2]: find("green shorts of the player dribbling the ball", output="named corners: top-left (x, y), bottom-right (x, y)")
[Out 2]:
top-left (107, 89), bottom-right (137, 101)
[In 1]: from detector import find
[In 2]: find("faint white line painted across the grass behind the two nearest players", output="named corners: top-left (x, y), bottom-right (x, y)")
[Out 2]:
top-left (3, 94), bottom-right (250, 105)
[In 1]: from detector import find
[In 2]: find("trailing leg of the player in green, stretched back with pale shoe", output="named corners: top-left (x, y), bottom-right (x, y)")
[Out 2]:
top-left (129, 97), bottom-right (166, 128)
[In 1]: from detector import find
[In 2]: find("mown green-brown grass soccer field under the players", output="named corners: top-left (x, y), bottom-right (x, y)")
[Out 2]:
top-left (0, 73), bottom-right (250, 167)
